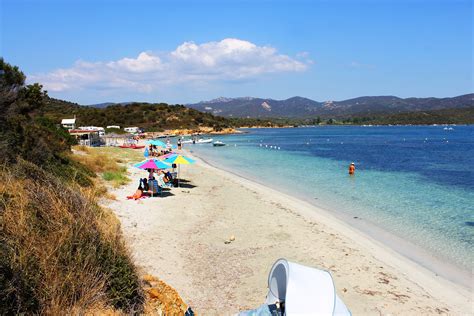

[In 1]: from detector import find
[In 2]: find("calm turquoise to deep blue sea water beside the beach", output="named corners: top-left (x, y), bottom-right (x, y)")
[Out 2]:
top-left (187, 126), bottom-right (474, 271)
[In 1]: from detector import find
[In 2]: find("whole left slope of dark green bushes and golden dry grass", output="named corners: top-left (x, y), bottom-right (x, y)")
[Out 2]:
top-left (0, 59), bottom-right (144, 315)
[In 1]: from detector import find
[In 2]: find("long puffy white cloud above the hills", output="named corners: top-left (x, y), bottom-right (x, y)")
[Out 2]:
top-left (29, 38), bottom-right (311, 92)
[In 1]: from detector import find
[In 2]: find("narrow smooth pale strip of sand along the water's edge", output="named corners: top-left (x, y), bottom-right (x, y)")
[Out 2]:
top-left (190, 151), bottom-right (474, 291)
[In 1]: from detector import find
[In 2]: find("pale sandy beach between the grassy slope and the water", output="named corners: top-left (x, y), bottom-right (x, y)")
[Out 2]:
top-left (104, 151), bottom-right (474, 315)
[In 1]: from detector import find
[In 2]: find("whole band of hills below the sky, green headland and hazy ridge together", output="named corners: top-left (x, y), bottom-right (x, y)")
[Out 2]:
top-left (38, 94), bottom-right (474, 131)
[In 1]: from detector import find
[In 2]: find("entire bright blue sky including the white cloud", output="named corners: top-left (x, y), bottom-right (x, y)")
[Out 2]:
top-left (0, 0), bottom-right (474, 104)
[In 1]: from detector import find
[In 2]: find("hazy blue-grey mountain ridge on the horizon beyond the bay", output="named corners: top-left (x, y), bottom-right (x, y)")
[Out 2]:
top-left (187, 94), bottom-right (474, 118)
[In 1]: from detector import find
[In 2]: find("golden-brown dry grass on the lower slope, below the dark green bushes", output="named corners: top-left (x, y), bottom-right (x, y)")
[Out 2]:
top-left (0, 165), bottom-right (143, 315)
